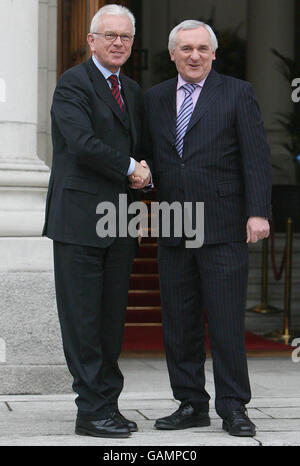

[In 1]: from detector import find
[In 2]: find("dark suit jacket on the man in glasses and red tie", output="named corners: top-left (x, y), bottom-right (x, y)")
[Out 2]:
top-left (43, 58), bottom-right (143, 247)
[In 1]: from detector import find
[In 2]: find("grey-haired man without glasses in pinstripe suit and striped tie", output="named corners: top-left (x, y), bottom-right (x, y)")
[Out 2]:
top-left (138, 21), bottom-right (271, 436)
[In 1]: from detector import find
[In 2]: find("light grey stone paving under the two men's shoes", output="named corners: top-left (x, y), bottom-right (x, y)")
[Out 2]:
top-left (0, 350), bottom-right (300, 447)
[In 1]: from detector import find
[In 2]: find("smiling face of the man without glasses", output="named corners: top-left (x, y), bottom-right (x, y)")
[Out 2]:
top-left (170, 26), bottom-right (216, 83)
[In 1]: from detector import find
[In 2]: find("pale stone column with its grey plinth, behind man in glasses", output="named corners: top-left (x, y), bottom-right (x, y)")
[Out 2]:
top-left (0, 0), bottom-right (71, 394)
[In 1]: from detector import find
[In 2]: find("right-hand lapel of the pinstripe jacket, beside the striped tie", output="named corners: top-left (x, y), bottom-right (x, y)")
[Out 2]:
top-left (186, 70), bottom-right (222, 134)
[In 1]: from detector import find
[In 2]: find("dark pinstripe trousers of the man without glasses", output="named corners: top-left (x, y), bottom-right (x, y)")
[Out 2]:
top-left (158, 242), bottom-right (251, 417)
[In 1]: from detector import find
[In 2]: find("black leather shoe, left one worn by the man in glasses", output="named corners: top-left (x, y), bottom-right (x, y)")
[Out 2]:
top-left (75, 418), bottom-right (130, 438)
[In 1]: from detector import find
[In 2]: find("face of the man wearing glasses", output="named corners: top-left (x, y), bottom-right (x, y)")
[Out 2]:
top-left (88, 15), bottom-right (133, 73)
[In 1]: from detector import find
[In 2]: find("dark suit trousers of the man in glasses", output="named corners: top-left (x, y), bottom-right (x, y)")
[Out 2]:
top-left (54, 238), bottom-right (137, 420)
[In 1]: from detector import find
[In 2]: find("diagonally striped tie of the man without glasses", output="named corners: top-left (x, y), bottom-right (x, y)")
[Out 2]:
top-left (175, 84), bottom-right (197, 157)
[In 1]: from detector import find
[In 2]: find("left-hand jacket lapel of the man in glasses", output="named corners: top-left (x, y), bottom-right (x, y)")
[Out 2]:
top-left (86, 58), bottom-right (125, 125)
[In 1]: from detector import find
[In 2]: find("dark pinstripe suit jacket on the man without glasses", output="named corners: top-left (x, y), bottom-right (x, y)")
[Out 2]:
top-left (144, 70), bottom-right (272, 245)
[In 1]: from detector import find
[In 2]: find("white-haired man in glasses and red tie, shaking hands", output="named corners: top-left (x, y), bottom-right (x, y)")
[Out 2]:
top-left (43, 5), bottom-right (149, 437)
